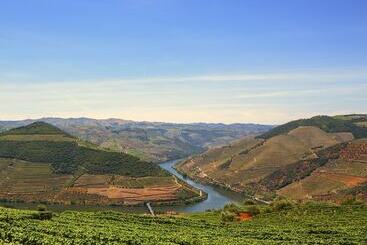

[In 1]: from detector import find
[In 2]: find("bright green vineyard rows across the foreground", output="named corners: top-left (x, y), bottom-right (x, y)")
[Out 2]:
top-left (0, 204), bottom-right (367, 245)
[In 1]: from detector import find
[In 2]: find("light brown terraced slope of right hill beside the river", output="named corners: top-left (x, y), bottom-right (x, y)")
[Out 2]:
top-left (178, 126), bottom-right (353, 190)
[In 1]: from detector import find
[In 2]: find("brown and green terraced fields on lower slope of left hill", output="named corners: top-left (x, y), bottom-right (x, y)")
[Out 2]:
top-left (0, 158), bottom-right (198, 205)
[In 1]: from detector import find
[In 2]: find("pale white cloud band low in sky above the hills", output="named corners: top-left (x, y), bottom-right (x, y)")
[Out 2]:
top-left (0, 69), bottom-right (367, 123)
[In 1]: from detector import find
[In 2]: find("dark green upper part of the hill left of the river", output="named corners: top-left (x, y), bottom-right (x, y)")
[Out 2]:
top-left (0, 122), bottom-right (165, 177)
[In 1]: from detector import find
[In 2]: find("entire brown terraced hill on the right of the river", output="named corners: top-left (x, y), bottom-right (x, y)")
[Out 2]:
top-left (177, 115), bottom-right (367, 203)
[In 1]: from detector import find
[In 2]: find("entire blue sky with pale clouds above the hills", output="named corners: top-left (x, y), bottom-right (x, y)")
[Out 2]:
top-left (0, 0), bottom-right (367, 123)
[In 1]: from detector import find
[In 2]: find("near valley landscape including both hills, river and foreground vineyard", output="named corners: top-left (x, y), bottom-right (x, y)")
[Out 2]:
top-left (0, 115), bottom-right (367, 245)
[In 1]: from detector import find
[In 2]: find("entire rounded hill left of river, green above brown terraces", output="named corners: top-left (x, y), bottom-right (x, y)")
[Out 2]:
top-left (0, 122), bottom-right (203, 205)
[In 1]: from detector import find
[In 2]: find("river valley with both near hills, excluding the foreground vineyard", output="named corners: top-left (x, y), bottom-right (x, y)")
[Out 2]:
top-left (0, 115), bottom-right (367, 209)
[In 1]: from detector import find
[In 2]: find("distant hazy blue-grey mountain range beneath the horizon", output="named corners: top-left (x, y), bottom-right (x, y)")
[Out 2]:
top-left (0, 118), bottom-right (273, 162)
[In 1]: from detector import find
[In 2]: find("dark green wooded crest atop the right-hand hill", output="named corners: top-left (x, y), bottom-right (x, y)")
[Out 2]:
top-left (258, 116), bottom-right (367, 139)
